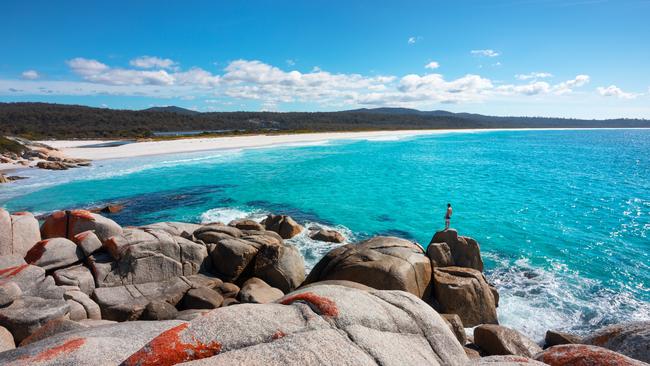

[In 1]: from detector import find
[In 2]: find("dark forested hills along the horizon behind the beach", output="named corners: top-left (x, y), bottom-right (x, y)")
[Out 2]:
top-left (0, 103), bottom-right (650, 139)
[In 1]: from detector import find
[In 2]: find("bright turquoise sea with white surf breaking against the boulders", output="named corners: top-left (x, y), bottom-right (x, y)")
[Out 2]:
top-left (0, 130), bottom-right (650, 339)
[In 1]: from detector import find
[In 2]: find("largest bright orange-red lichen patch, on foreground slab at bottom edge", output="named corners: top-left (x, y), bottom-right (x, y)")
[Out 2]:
top-left (122, 323), bottom-right (221, 366)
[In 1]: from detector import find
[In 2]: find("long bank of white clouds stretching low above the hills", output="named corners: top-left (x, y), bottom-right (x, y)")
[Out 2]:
top-left (0, 58), bottom-right (600, 109)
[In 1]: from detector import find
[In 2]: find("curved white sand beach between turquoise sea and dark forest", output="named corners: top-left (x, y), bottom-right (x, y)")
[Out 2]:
top-left (38, 128), bottom-right (645, 162)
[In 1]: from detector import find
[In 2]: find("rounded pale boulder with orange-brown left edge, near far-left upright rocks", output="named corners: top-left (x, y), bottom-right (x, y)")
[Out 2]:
top-left (25, 238), bottom-right (84, 271)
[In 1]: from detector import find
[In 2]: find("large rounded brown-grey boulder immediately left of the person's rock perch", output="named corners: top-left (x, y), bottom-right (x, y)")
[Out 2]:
top-left (304, 236), bottom-right (431, 298)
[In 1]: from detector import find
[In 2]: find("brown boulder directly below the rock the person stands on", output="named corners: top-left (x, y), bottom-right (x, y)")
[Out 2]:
top-left (433, 267), bottom-right (498, 327)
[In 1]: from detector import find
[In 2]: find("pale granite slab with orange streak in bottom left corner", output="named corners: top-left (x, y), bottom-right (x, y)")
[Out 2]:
top-left (0, 320), bottom-right (183, 366)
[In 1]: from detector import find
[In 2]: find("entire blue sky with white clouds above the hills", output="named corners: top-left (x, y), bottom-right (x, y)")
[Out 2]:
top-left (0, 0), bottom-right (650, 119)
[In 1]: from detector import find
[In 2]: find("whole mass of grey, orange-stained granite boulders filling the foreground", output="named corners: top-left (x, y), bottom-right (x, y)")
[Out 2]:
top-left (0, 209), bottom-right (650, 365)
